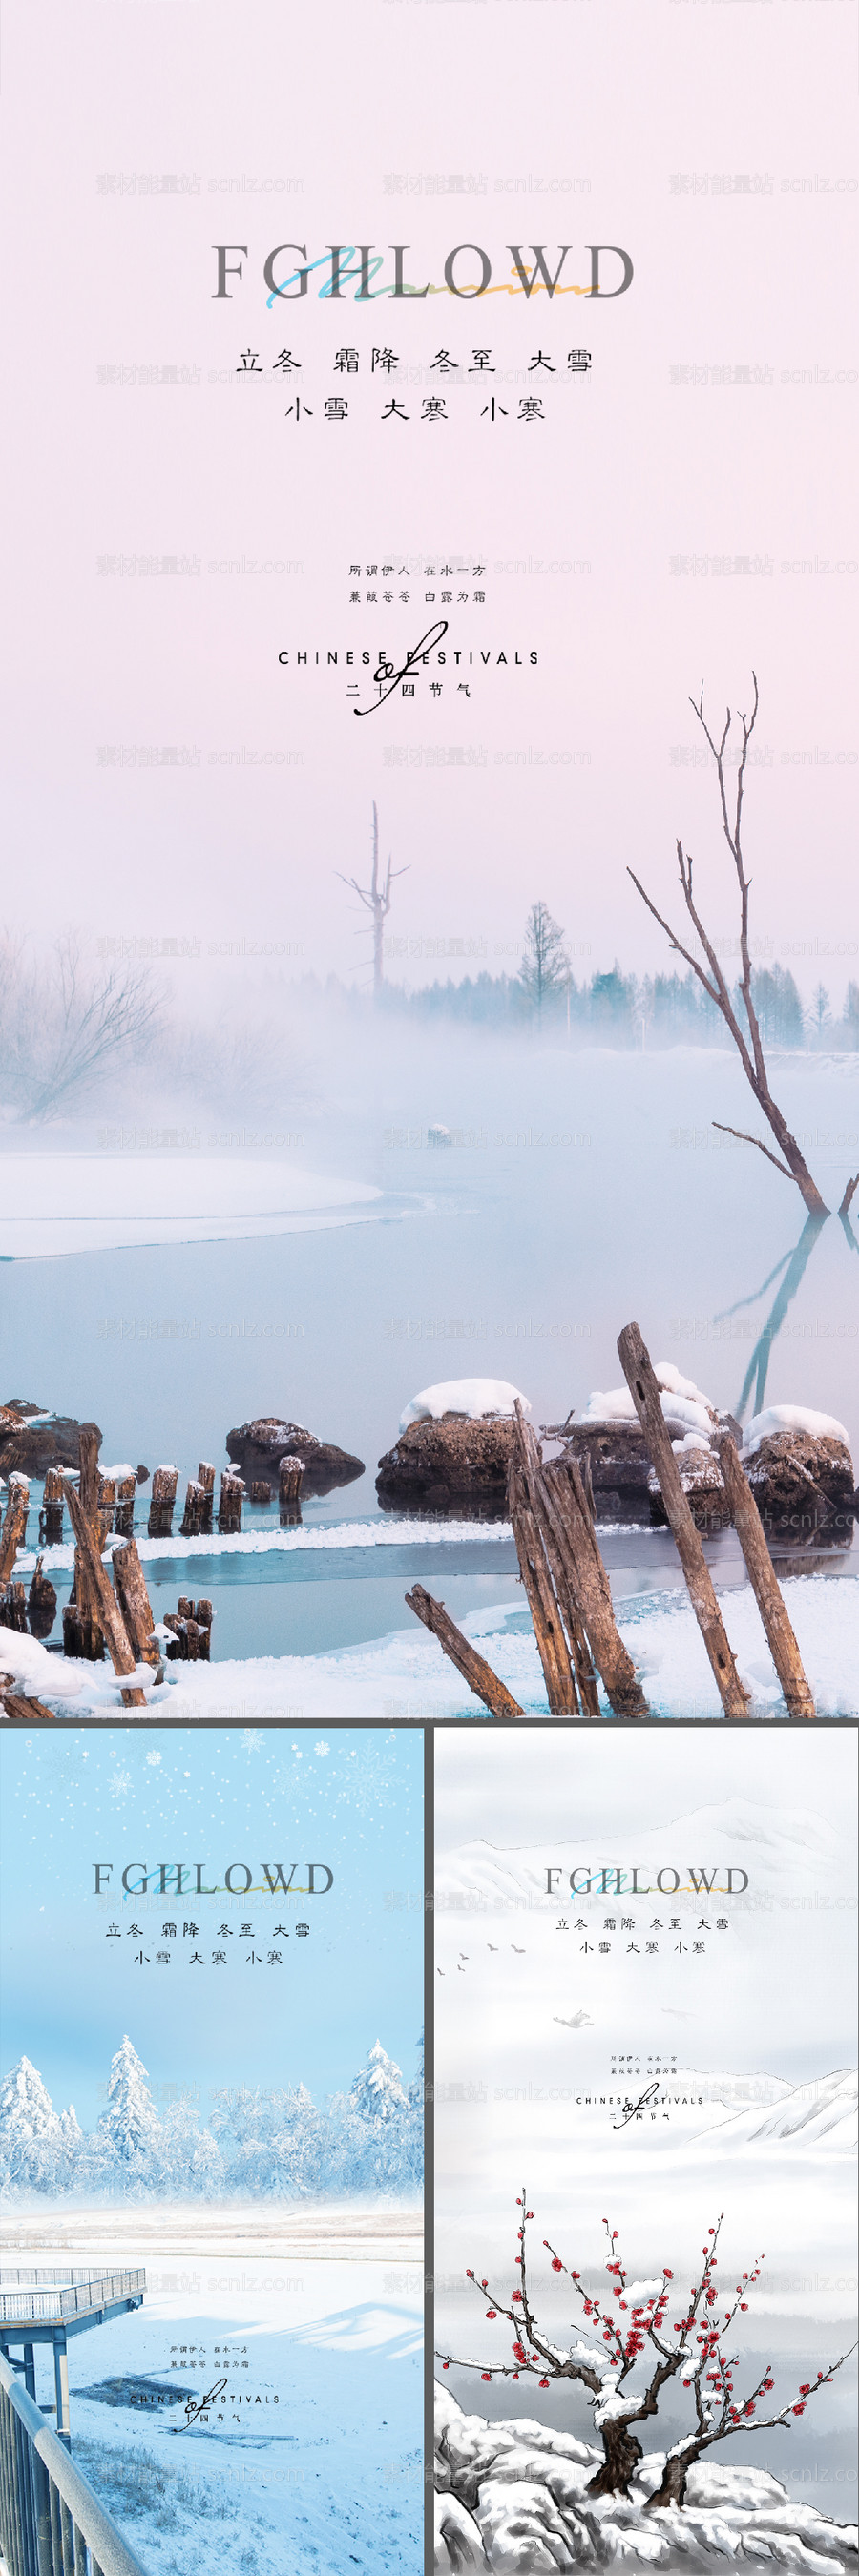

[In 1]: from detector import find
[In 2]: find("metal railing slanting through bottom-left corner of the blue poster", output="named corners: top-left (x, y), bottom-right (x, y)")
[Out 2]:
top-left (0, 2355), bottom-right (147, 2576)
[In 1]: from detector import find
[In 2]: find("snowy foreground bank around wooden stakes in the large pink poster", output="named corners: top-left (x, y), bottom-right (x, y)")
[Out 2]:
top-left (0, 1574), bottom-right (859, 1723)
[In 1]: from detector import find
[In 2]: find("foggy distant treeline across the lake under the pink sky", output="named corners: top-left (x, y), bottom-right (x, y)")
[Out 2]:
top-left (0, 922), bottom-right (859, 1123)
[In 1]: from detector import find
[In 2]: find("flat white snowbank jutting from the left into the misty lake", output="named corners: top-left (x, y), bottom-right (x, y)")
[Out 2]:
top-left (0, 1154), bottom-right (382, 1259)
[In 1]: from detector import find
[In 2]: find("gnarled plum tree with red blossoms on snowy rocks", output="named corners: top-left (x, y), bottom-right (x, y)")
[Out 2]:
top-left (438, 2192), bottom-right (854, 2512)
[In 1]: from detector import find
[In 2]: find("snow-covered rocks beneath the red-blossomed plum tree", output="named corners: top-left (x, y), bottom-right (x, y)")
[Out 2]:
top-left (436, 2388), bottom-right (856, 2576)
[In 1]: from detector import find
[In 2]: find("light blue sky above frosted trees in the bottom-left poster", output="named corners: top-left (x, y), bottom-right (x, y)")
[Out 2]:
top-left (0, 1726), bottom-right (423, 2128)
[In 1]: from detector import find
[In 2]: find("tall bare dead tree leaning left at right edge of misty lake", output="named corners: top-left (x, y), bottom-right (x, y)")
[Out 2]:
top-left (627, 675), bottom-right (828, 1215)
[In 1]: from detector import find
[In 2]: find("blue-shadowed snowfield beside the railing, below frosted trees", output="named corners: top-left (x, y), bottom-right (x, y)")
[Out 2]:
top-left (3, 2211), bottom-right (423, 2576)
